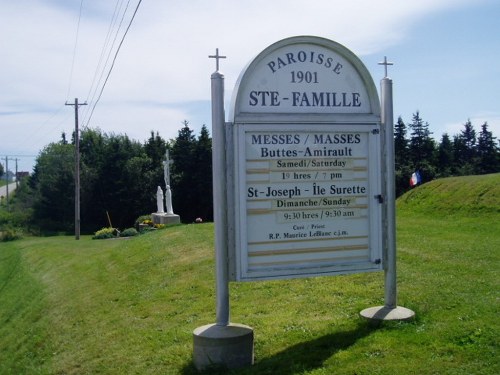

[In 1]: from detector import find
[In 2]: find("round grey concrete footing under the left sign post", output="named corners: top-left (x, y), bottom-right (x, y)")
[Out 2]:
top-left (193, 323), bottom-right (254, 371)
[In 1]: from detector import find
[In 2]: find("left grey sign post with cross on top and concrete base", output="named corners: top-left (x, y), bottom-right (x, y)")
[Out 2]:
top-left (193, 49), bottom-right (253, 370)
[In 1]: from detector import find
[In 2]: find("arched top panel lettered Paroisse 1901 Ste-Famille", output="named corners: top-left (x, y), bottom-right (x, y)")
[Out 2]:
top-left (236, 44), bottom-right (370, 113)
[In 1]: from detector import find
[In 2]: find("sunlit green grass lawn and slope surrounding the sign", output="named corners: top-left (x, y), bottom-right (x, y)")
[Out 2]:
top-left (0, 175), bottom-right (500, 375)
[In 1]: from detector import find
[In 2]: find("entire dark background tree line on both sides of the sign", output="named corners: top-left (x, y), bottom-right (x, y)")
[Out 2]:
top-left (3, 111), bottom-right (500, 233)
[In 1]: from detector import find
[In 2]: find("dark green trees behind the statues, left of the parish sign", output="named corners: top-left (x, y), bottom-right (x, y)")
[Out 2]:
top-left (8, 121), bottom-right (213, 233)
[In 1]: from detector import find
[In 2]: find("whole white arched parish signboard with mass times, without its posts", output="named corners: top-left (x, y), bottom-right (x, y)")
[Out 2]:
top-left (233, 38), bottom-right (382, 280)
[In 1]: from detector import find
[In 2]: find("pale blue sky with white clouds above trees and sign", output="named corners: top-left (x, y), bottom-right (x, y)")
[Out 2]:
top-left (0, 0), bottom-right (500, 171)
